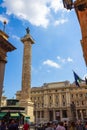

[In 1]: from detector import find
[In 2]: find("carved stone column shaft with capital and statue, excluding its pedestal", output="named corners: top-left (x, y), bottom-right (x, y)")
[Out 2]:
top-left (21, 28), bottom-right (34, 99)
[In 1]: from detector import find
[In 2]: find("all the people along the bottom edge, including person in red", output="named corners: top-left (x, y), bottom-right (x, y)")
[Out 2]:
top-left (0, 120), bottom-right (87, 130)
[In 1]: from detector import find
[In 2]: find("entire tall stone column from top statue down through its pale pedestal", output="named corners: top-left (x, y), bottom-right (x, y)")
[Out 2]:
top-left (20, 28), bottom-right (34, 122)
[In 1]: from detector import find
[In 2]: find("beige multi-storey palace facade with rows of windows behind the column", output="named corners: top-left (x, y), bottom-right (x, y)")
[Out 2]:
top-left (27, 81), bottom-right (87, 123)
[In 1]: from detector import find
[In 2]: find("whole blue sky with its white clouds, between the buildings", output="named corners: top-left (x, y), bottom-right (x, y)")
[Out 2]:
top-left (0, 0), bottom-right (87, 98)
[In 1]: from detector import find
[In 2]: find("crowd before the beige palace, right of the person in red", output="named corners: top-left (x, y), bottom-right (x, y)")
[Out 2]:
top-left (37, 121), bottom-right (87, 130)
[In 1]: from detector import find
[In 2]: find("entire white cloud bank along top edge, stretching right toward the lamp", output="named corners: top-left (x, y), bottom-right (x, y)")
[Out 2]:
top-left (2, 0), bottom-right (65, 28)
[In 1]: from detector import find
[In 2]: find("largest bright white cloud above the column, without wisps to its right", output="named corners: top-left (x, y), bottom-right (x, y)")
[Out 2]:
top-left (2, 0), bottom-right (50, 27)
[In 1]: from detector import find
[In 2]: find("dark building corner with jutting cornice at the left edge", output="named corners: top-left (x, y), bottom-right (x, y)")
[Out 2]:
top-left (0, 30), bottom-right (16, 106)
